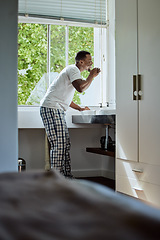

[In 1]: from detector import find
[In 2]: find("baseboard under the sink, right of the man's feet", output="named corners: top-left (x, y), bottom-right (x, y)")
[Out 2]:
top-left (72, 169), bottom-right (115, 180)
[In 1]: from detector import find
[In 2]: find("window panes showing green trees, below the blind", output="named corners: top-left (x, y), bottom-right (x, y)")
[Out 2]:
top-left (18, 19), bottom-right (106, 106)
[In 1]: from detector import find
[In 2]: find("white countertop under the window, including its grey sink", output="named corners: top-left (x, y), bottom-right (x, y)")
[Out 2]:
top-left (18, 107), bottom-right (115, 129)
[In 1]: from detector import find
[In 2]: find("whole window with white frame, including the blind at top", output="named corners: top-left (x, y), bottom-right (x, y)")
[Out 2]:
top-left (18, 0), bottom-right (115, 106)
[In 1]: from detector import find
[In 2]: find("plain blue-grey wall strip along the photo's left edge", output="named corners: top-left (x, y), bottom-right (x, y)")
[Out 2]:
top-left (0, 0), bottom-right (18, 172)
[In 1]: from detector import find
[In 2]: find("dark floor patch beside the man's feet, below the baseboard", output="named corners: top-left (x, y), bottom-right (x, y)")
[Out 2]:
top-left (78, 177), bottom-right (115, 190)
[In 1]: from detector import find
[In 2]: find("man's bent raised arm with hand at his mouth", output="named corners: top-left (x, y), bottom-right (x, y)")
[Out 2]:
top-left (72, 68), bottom-right (100, 93)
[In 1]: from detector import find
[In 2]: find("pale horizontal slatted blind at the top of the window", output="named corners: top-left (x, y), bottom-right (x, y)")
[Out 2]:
top-left (18, 0), bottom-right (107, 25)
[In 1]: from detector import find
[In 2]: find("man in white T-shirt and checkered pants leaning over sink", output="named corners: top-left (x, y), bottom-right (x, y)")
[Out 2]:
top-left (40, 51), bottom-right (100, 178)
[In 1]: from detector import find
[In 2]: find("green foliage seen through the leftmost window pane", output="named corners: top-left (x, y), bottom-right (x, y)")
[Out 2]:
top-left (18, 23), bottom-right (47, 105)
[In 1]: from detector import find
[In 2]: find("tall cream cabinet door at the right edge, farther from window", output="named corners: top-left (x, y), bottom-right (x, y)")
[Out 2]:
top-left (138, 0), bottom-right (160, 165)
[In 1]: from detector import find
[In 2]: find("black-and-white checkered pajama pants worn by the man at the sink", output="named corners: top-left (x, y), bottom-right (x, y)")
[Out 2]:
top-left (40, 107), bottom-right (72, 177)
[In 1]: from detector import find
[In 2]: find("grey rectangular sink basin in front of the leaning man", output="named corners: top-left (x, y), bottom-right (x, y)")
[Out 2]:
top-left (72, 113), bottom-right (115, 124)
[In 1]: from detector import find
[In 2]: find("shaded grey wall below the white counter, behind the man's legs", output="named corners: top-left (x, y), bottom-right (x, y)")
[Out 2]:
top-left (19, 127), bottom-right (115, 179)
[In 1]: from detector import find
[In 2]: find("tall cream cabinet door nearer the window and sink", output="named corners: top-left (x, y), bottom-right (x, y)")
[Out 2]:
top-left (115, 0), bottom-right (138, 161)
